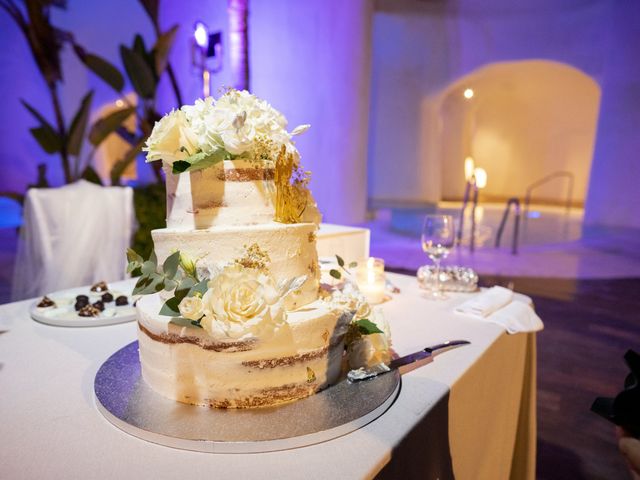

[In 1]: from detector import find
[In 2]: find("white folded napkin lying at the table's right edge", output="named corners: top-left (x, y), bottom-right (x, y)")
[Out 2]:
top-left (455, 287), bottom-right (544, 334)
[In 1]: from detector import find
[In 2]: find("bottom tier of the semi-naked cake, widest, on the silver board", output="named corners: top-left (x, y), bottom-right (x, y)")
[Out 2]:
top-left (137, 294), bottom-right (350, 408)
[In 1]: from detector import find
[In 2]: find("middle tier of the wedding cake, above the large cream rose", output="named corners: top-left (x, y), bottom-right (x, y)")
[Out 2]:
top-left (151, 222), bottom-right (320, 309)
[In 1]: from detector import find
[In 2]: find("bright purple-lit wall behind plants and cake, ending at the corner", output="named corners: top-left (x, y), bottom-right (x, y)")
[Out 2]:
top-left (0, 0), bottom-right (371, 222)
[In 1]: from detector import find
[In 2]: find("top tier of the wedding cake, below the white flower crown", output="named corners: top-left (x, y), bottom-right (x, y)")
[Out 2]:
top-left (167, 160), bottom-right (276, 230)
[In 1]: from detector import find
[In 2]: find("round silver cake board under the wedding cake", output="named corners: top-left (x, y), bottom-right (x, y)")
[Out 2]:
top-left (94, 341), bottom-right (400, 453)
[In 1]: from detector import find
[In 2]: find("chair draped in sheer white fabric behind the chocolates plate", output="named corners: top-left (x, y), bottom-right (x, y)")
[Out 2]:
top-left (11, 180), bottom-right (135, 301)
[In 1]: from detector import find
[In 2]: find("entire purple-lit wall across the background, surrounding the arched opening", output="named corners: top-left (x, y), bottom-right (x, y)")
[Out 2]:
top-left (0, 0), bottom-right (640, 227)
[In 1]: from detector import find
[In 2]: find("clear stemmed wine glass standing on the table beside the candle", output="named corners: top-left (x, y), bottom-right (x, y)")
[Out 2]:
top-left (422, 215), bottom-right (455, 300)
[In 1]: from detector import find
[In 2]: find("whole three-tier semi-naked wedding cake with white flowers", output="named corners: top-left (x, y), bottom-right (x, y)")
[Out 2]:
top-left (129, 90), bottom-right (388, 408)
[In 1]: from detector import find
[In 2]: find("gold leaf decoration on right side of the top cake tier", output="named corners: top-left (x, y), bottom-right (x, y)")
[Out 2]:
top-left (275, 145), bottom-right (309, 223)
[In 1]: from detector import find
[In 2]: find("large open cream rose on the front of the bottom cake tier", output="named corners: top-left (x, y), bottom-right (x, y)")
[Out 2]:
top-left (201, 265), bottom-right (286, 338)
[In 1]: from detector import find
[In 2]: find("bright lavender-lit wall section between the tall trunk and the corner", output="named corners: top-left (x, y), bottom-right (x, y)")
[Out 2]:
top-left (249, 0), bottom-right (372, 223)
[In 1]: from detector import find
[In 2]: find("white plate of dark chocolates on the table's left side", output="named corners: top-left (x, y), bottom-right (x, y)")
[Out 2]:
top-left (30, 282), bottom-right (136, 327)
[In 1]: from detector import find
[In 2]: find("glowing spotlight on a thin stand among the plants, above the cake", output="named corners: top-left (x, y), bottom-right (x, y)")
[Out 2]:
top-left (191, 21), bottom-right (222, 97)
